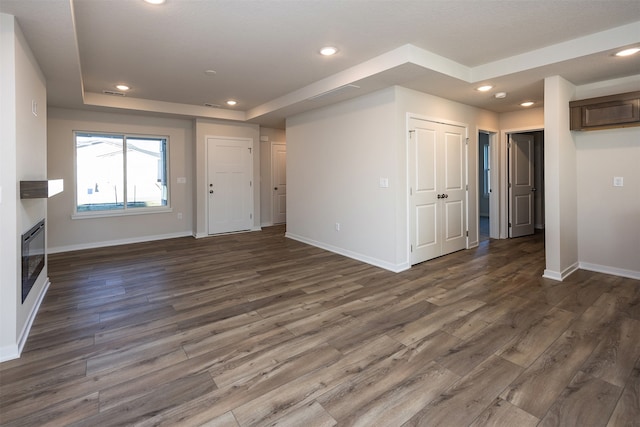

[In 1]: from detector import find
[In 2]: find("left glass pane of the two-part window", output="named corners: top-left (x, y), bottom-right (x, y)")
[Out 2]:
top-left (76, 133), bottom-right (124, 212)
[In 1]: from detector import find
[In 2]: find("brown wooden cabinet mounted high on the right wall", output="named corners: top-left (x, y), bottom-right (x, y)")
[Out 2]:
top-left (569, 91), bottom-right (640, 130)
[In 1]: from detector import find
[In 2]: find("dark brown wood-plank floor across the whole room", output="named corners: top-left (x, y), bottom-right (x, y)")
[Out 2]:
top-left (0, 227), bottom-right (640, 427)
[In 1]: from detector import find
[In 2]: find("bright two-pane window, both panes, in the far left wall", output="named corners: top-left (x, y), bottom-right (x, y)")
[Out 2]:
top-left (75, 132), bottom-right (169, 215)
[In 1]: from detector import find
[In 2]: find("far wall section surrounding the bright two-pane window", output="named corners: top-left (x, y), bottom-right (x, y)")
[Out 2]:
top-left (48, 108), bottom-right (194, 252)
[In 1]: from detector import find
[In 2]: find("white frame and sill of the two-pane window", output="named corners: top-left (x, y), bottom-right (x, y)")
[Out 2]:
top-left (71, 130), bottom-right (173, 219)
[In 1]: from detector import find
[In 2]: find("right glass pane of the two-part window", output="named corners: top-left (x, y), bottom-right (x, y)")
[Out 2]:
top-left (127, 137), bottom-right (167, 208)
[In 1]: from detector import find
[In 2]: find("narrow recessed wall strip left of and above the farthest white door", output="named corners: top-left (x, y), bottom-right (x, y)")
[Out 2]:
top-left (260, 127), bottom-right (287, 227)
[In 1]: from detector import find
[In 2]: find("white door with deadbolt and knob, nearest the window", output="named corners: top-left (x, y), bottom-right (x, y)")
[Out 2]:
top-left (207, 138), bottom-right (253, 234)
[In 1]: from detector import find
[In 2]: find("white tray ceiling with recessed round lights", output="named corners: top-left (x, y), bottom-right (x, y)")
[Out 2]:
top-left (0, 0), bottom-right (640, 127)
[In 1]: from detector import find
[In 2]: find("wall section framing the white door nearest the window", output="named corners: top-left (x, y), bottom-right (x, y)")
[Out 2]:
top-left (193, 119), bottom-right (260, 237)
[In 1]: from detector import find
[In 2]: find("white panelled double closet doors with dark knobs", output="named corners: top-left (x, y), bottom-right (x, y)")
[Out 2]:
top-left (408, 119), bottom-right (467, 265)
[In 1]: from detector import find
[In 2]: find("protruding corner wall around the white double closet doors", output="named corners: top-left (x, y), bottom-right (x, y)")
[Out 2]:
top-left (287, 87), bottom-right (498, 271)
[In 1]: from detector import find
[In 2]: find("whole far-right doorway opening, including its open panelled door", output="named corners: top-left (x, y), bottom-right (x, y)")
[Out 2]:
top-left (507, 130), bottom-right (544, 238)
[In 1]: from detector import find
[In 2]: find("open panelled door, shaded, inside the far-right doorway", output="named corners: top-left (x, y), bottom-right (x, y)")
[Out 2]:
top-left (509, 134), bottom-right (536, 237)
